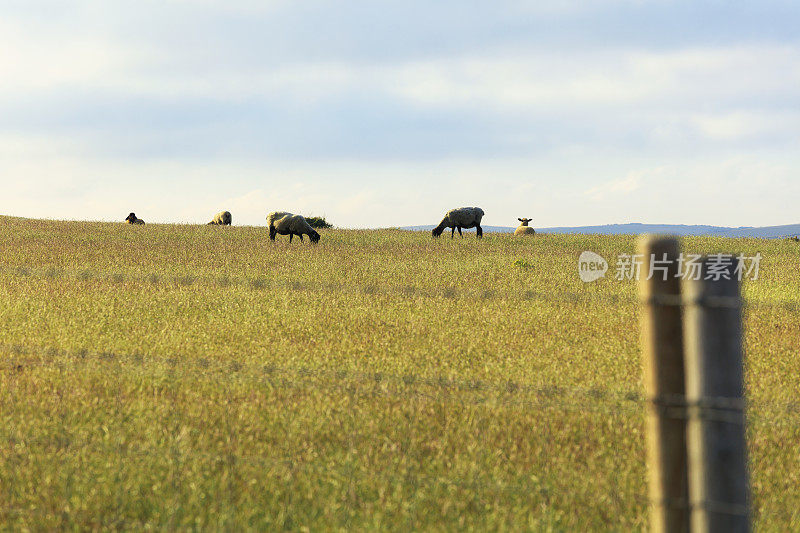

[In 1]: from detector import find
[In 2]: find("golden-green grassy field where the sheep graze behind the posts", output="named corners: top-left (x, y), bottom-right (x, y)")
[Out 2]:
top-left (0, 217), bottom-right (800, 531)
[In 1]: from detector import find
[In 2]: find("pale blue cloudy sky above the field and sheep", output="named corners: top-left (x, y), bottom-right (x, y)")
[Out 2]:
top-left (0, 0), bottom-right (800, 228)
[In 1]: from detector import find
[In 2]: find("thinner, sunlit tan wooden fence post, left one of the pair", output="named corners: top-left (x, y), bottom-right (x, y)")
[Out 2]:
top-left (638, 236), bottom-right (689, 533)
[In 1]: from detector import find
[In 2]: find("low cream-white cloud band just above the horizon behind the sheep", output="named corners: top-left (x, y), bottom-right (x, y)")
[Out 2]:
top-left (0, 144), bottom-right (800, 227)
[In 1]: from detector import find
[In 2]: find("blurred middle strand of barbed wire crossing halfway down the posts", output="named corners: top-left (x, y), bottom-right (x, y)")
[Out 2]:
top-left (0, 343), bottom-right (800, 424)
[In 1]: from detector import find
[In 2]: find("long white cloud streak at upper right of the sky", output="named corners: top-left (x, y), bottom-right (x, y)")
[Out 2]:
top-left (389, 45), bottom-right (800, 112)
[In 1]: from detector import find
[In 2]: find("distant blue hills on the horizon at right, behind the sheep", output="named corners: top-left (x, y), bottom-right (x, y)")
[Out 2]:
top-left (400, 224), bottom-right (800, 239)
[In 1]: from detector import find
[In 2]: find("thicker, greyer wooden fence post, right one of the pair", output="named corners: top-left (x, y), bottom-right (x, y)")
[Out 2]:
top-left (685, 255), bottom-right (750, 533)
